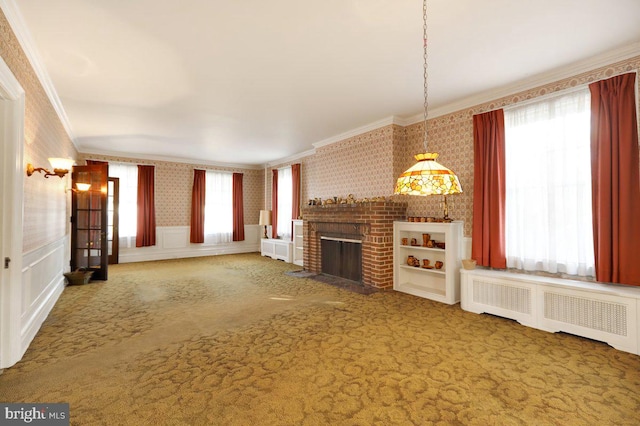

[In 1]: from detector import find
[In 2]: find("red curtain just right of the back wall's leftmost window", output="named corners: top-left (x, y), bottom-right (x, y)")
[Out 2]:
top-left (136, 165), bottom-right (156, 247)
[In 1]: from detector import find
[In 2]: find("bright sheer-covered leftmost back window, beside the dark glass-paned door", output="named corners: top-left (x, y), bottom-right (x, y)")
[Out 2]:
top-left (109, 163), bottom-right (138, 248)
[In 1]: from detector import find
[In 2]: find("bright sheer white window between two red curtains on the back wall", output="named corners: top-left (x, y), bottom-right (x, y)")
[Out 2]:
top-left (204, 171), bottom-right (233, 244)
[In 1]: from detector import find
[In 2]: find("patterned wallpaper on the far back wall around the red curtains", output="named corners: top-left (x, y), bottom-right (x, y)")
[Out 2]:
top-left (78, 153), bottom-right (264, 226)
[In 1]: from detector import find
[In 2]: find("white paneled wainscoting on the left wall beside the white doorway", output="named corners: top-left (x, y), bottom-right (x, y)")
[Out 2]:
top-left (20, 236), bottom-right (69, 356)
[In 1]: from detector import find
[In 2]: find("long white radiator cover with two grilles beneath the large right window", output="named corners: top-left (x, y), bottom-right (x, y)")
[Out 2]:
top-left (460, 269), bottom-right (640, 355)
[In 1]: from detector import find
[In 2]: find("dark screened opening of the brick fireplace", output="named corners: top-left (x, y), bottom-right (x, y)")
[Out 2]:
top-left (320, 236), bottom-right (362, 282)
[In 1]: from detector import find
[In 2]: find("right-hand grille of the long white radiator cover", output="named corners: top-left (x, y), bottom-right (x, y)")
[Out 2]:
top-left (544, 292), bottom-right (627, 336)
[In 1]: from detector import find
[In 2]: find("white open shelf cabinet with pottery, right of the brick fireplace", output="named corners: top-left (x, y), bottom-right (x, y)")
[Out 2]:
top-left (393, 221), bottom-right (463, 305)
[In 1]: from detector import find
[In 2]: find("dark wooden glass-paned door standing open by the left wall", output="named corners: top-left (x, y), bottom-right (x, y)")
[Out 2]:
top-left (71, 164), bottom-right (109, 280)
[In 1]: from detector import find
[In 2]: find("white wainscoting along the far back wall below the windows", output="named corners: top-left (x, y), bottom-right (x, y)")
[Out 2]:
top-left (118, 225), bottom-right (264, 263)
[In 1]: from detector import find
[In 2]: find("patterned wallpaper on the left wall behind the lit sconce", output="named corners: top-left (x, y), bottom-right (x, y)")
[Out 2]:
top-left (0, 10), bottom-right (77, 253)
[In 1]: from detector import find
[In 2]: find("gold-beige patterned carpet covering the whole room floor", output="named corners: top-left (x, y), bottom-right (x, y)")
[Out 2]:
top-left (0, 254), bottom-right (640, 425)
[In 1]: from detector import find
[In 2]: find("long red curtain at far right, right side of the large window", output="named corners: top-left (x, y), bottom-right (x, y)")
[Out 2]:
top-left (589, 73), bottom-right (640, 285)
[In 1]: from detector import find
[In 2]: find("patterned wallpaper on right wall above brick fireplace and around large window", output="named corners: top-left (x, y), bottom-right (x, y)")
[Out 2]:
top-left (267, 56), bottom-right (640, 237)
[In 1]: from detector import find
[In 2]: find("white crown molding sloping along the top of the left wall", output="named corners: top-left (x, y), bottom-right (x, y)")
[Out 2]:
top-left (0, 0), bottom-right (78, 143)
